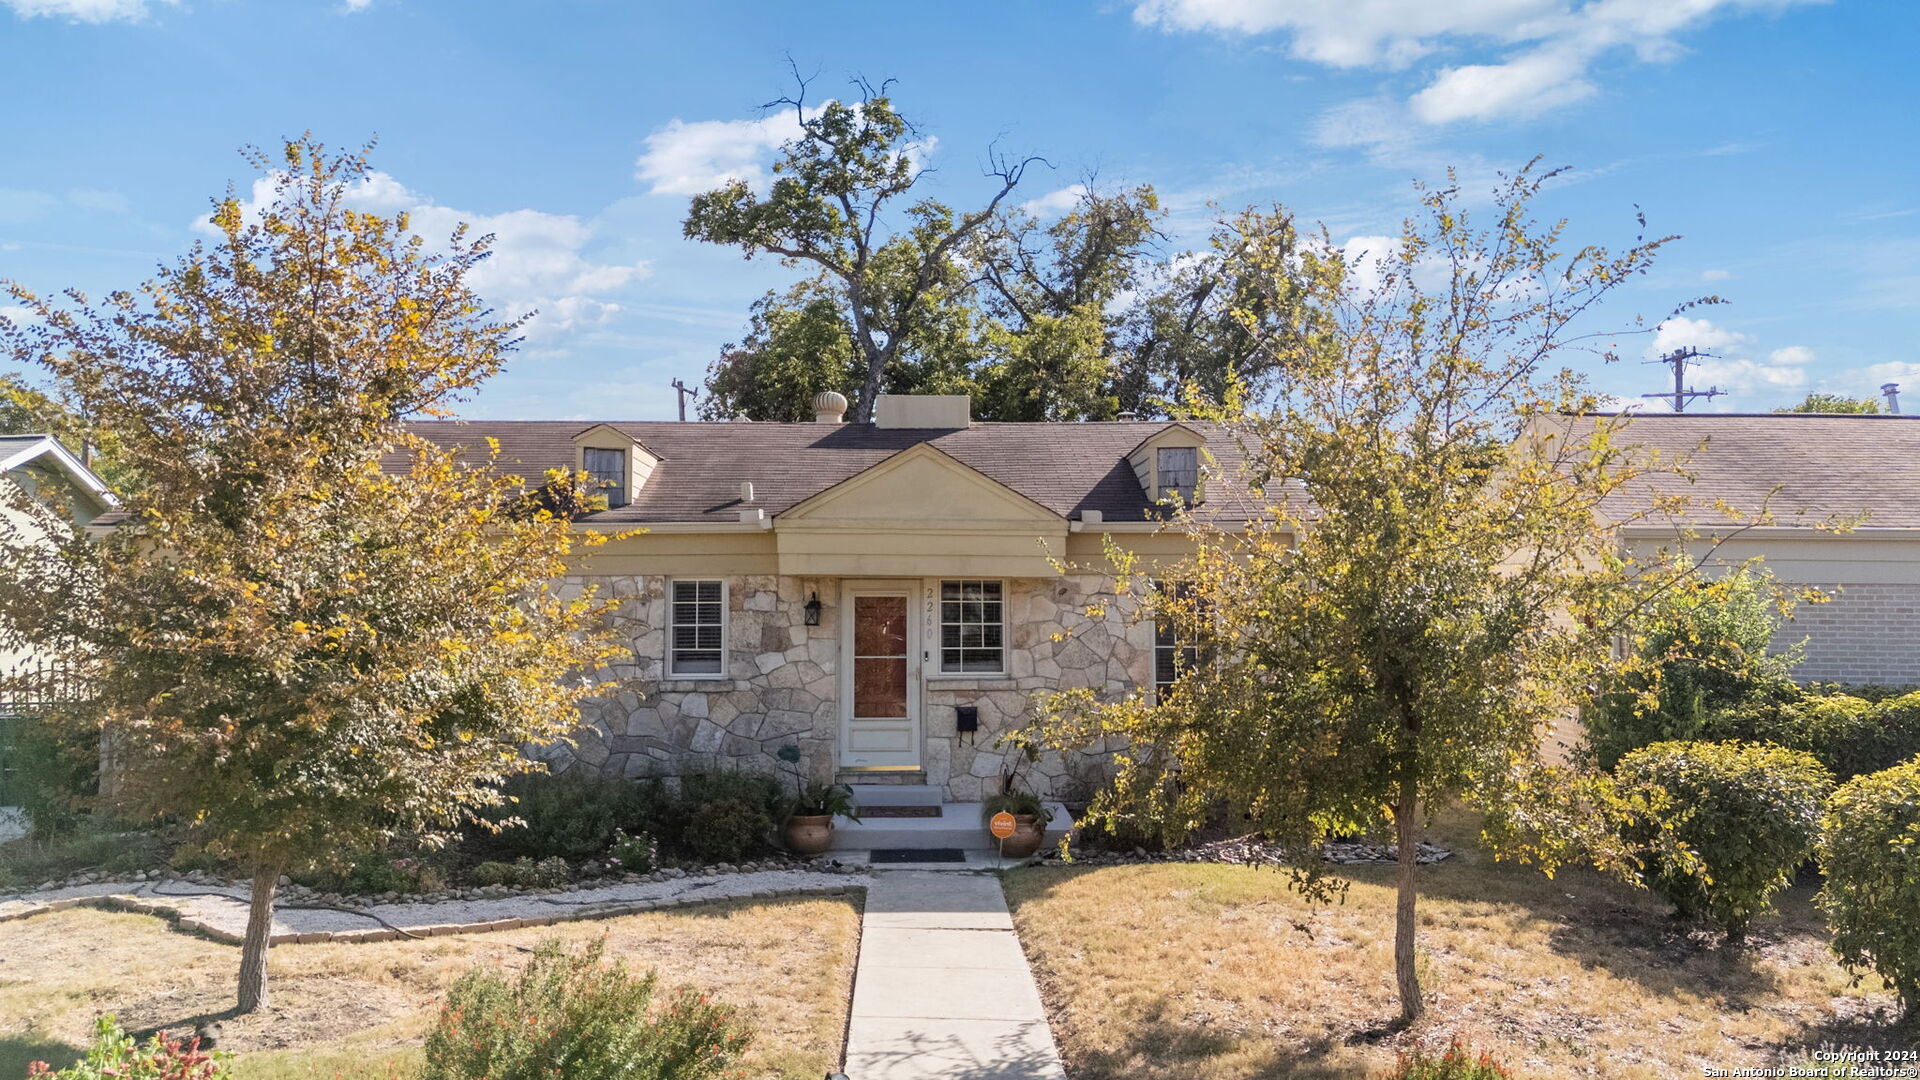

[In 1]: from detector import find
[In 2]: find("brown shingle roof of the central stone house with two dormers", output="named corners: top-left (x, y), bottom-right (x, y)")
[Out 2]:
top-left (407, 421), bottom-right (1238, 523)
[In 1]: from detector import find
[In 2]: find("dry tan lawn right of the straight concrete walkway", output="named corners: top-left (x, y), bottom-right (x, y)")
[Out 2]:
top-left (1006, 818), bottom-right (1920, 1080)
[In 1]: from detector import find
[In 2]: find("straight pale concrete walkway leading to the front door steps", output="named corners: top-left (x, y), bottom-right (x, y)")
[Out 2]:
top-left (845, 871), bottom-right (1066, 1080)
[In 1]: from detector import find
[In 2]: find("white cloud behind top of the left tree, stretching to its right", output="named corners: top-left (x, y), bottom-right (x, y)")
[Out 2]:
top-left (194, 173), bottom-right (651, 338)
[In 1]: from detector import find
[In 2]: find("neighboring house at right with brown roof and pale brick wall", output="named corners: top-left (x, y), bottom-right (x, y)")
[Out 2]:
top-left (1589, 413), bottom-right (1920, 684)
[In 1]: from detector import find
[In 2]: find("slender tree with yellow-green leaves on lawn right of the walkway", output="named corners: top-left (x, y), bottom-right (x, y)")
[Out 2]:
top-left (1023, 167), bottom-right (1728, 1022)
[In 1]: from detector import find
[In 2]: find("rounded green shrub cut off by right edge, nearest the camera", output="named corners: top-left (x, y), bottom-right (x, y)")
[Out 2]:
top-left (1818, 757), bottom-right (1920, 1013)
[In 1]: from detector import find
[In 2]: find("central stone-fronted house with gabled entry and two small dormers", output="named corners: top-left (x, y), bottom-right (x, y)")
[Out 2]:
top-left (411, 394), bottom-right (1244, 801)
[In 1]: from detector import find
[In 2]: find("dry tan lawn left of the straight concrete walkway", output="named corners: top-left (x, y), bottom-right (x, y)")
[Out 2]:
top-left (0, 899), bottom-right (860, 1080)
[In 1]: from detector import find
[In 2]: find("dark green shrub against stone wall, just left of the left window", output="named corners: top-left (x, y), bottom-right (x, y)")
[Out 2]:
top-left (470, 769), bottom-right (653, 859)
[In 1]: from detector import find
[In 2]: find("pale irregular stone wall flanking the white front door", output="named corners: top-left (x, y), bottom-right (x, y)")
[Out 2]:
top-left (545, 575), bottom-right (1152, 801)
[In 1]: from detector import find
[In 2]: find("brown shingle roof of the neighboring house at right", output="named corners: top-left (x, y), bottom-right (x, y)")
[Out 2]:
top-left (1566, 413), bottom-right (1920, 528)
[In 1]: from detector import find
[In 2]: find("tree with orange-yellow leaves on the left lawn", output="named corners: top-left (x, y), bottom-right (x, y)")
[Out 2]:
top-left (0, 138), bottom-right (609, 1011)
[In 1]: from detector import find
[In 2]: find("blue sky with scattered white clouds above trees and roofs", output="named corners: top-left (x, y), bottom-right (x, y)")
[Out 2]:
top-left (0, 0), bottom-right (1920, 419)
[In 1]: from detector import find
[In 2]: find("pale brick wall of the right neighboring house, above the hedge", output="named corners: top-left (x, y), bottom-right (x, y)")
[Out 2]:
top-left (1778, 584), bottom-right (1920, 684)
